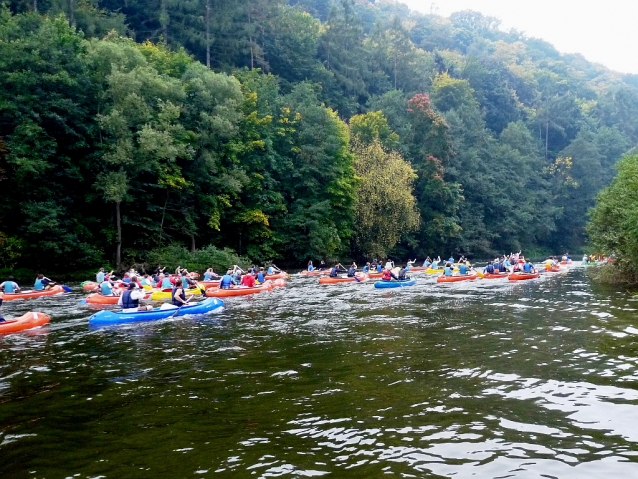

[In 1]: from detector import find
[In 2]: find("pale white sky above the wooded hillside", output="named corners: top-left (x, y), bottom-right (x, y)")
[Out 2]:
top-left (399, 0), bottom-right (638, 74)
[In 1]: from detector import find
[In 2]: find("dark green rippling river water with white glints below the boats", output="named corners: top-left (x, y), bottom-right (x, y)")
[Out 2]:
top-left (0, 267), bottom-right (638, 479)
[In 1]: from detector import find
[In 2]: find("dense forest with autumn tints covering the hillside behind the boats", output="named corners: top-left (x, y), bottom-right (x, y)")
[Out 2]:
top-left (0, 0), bottom-right (638, 269)
